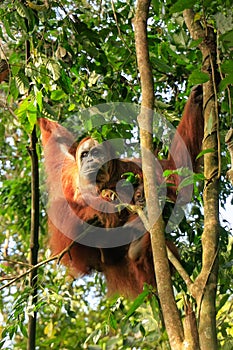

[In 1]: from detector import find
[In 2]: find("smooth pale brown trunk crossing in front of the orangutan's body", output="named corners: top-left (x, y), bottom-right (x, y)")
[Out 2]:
top-left (134, 0), bottom-right (183, 350)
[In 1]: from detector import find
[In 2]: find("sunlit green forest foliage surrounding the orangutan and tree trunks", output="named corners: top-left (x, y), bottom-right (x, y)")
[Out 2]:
top-left (0, 0), bottom-right (233, 350)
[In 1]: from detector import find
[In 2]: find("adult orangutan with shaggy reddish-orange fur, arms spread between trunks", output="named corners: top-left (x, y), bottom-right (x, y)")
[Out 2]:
top-left (39, 86), bottom-right (203, 297)
